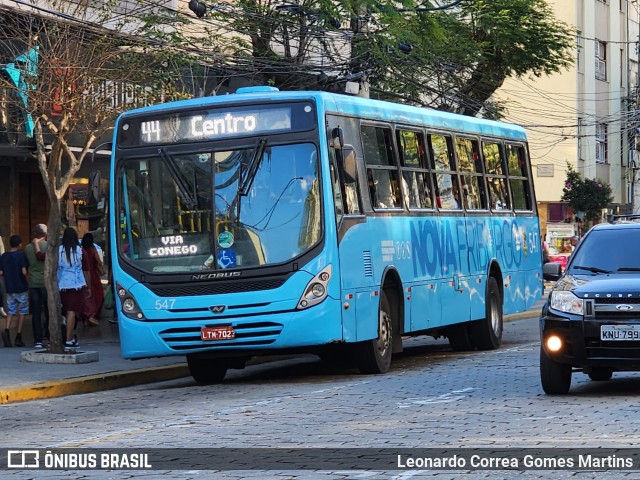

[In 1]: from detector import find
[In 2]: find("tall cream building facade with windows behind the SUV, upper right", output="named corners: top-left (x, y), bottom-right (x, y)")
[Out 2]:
top-left (497, 0), bottom-right (640, 238)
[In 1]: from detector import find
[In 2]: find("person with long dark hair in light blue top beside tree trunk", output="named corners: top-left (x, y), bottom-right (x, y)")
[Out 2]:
top-left (58, 227), bottom-right (91, 348)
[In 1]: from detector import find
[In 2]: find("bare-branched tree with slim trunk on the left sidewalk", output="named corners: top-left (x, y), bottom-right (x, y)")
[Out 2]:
top-left (0, 2), bottom-right (185, 353)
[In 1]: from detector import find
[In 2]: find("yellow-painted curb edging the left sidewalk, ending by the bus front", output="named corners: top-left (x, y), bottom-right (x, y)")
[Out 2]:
top-left (0, 363), bottom-right (191, 404)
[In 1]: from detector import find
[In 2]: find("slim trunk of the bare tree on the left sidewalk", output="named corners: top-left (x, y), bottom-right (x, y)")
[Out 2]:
top-left (44, 195), bottom-right (64, 353)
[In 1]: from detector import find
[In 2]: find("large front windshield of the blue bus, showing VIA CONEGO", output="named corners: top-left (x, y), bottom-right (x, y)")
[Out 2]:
top-left (116, 139), bottom-right (322, 272)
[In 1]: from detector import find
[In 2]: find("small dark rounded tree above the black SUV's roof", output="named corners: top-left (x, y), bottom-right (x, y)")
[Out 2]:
top-left (561, 164), bottom-right (613, 223)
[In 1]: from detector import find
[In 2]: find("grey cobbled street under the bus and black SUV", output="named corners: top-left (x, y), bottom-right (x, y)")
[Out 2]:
top-left (2, 319), bottom-right (640, 479)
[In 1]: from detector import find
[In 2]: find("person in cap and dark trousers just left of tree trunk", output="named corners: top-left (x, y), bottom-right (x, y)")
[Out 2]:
top-left (24, 223), bottom-right (49, 348)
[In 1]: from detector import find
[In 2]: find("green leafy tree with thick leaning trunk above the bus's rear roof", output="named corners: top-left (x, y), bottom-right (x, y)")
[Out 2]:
top-left (362, 0), bottom-right (575, 118)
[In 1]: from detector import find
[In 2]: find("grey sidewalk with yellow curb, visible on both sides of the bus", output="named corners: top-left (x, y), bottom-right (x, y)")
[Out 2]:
top-left (0, 300), bottom-right (543, 404)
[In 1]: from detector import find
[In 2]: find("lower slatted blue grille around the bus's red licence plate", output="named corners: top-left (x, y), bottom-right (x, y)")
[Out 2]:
top-left (159, 322), bottom-right (283, 352)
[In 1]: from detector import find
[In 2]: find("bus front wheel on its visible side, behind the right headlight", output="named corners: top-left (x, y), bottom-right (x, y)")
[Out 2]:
top-left (356, 291), bottom-right (394, 373)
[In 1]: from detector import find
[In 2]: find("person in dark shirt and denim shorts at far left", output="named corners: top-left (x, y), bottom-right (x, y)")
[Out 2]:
top-left (0, 235), bottom-right (29, 347)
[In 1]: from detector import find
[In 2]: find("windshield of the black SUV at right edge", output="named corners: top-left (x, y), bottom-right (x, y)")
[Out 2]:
top-left (567, 228), bottom-right (640, 275)
